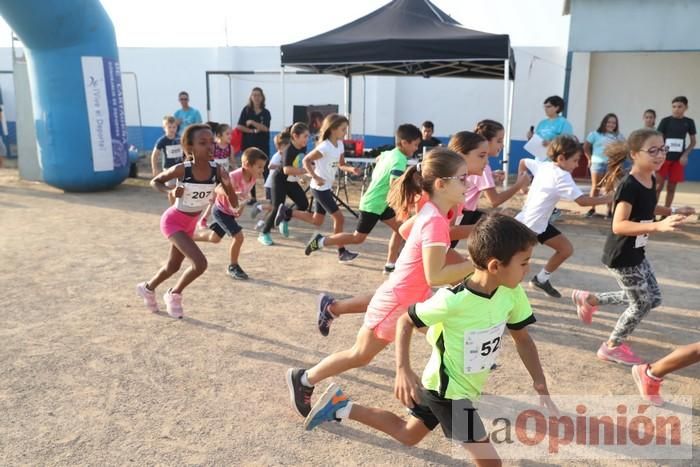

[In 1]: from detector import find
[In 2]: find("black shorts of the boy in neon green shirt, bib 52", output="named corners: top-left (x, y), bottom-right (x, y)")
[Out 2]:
top-left (409, 389), bottom-right (487, 443)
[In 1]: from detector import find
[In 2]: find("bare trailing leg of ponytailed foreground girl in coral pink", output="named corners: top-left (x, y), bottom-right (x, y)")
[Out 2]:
top-left (306, 326), bottom-right (390, 386)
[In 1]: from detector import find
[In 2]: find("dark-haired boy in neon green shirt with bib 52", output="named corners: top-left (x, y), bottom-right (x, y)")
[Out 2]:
top-left (304, 215), bottom-right (557, 465)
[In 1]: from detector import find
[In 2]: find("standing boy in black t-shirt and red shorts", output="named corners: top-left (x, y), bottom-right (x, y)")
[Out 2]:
top-left (656, 96), bottom-right (696, 208)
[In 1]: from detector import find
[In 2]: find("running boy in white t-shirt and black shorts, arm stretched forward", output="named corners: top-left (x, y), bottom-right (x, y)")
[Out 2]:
top-left (515, 135), bottom-right (612, 298)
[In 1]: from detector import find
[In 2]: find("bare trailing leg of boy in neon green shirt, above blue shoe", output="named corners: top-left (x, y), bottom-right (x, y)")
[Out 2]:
top-left (349, 403), bottom-right (430, 446)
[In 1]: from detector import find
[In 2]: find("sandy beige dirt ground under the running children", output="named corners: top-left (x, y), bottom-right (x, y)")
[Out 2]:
top-left (0, 169), bottom-right (700, 466)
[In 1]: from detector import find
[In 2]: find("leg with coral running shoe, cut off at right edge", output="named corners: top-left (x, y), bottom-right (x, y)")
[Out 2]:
top-left (632, 342), bottom-right (700, 406)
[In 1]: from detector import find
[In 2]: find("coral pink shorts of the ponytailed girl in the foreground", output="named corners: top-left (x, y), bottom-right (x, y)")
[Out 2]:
top-left (364, 282), bottom-right (432, 342)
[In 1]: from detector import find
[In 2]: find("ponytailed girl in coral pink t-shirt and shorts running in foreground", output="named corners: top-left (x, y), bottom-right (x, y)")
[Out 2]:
top-left (287, 148), bottom-right (473, 417)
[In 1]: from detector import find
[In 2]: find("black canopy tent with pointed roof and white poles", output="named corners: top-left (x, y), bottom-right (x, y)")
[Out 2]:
top-left (281, 0), bottom-right (515, 177)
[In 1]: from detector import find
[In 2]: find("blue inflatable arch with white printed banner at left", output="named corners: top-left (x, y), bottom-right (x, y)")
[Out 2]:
top-left (0, 0), bottom-right (129, 191)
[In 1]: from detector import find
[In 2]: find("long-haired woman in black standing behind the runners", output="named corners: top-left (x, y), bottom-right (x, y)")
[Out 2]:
top-left (237, 87), bottom-right (272, 203)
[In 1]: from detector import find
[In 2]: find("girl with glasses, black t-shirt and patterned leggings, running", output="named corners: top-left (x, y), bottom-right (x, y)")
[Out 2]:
top-left (571, 129), bottom-right (695, 365)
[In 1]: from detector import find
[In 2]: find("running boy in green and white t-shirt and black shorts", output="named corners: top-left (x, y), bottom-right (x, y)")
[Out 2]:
top-left (304, 123), bottom-right (421, 274)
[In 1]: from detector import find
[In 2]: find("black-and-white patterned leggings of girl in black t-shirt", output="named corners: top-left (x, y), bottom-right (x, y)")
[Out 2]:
top-left (596, 258), bottom-right (661, 346)
